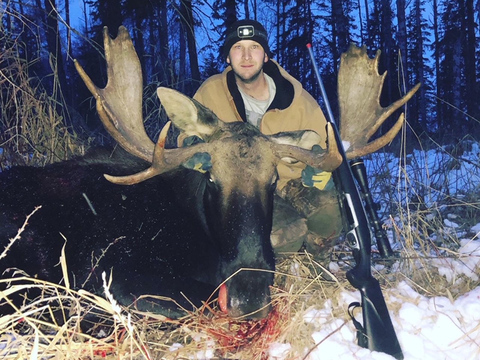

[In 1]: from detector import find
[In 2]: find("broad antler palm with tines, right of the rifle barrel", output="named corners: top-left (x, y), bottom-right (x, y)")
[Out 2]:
top-left (338, 44), bottom-right (420, 159)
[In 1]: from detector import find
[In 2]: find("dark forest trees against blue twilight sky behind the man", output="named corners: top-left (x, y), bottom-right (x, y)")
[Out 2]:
top-left (0, 0), bottom-right (480, 150)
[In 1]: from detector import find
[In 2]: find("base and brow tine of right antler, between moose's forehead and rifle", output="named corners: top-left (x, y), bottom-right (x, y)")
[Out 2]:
top-left (273, 123), bottom-right (342, 172)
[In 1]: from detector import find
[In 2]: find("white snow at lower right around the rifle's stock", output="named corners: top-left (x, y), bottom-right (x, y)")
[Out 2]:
top-left (269, 236), bottom-right (480, 360)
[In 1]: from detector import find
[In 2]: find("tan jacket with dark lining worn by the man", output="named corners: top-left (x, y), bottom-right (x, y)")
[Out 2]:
top-left (194, 60), bottom-right (326, 189)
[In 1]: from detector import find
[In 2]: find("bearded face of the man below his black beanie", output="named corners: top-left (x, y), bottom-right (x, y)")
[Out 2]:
top-left (227, 40), bottom-right (268, 84)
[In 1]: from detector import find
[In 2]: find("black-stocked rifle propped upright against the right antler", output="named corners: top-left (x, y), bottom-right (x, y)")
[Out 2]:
top-left (307, 44), bottom-right (403, 359)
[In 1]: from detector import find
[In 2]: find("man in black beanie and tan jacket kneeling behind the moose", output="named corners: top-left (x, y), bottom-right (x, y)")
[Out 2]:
top-left (194, 20), bottom-right (341, 252)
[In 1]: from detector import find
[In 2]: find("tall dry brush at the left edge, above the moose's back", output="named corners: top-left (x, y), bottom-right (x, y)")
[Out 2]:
top-left (0, 23), bottom-right (85, 169)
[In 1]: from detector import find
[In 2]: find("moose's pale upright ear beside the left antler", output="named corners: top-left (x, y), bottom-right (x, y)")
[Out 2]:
top-left (157, 87), bottom-right (220, 139)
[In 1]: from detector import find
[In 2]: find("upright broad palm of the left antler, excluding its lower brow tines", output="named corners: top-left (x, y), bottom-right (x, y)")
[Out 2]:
top-left (75, 26), bottom-right (155, 162)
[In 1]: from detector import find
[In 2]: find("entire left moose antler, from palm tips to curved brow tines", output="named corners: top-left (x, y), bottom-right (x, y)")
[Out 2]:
top-left (75, 26), bottom-right (213, 185)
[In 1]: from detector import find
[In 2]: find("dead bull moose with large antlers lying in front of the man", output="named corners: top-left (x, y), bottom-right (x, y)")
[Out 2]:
top-left (0, 27), bottom-right (418, 319)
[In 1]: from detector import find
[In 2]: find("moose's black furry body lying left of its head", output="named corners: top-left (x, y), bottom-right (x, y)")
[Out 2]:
top-left (0, 152), bottom-right (220, 316)
